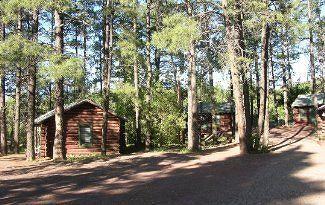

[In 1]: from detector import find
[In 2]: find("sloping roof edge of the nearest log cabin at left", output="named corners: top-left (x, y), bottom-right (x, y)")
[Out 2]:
top-left (35, 99), bottom-right (126, 124)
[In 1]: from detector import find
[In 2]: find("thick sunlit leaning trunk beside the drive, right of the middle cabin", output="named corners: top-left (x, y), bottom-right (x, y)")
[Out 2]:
top-left (222, 0), bottom-right (251, 154)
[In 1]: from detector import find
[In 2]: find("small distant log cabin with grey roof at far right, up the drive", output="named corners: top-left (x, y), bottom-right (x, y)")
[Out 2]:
top-left (291, 93), bottom-right (325, 124)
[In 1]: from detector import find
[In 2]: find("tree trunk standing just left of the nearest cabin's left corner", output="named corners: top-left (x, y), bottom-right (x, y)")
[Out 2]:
top-left (26, 10), bottom-right (39, 161)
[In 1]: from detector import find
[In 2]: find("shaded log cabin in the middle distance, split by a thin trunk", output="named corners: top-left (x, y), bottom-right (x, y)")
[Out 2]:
top-left (198, 102), bottom-right (235, 136)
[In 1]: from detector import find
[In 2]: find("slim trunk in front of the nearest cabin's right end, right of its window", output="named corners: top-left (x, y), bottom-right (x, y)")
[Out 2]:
top-left (101, 0), bottom-right (113, 155)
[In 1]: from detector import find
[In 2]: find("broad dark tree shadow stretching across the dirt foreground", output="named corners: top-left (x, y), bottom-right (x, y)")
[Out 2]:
top-left (0, 143), bottom-right (325, 205)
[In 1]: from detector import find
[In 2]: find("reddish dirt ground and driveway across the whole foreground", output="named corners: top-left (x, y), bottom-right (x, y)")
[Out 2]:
top-left (0, 126), bottom-right (325, 205)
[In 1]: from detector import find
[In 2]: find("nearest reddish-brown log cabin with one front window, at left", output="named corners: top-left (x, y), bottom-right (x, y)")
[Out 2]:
top-left (35, 100), bottom-right (125, 158)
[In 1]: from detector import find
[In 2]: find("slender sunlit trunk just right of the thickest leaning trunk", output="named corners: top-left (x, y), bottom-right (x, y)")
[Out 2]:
top-left (258, 18), bottom-right (270, 138)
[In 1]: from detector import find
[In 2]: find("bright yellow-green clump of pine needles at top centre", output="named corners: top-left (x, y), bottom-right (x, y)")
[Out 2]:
top-left (153, 13), bottom-right (201, 53)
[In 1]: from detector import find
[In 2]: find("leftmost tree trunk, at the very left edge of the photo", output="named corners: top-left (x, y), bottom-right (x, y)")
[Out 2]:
top-left (0, 22), bottom-right (7, 155)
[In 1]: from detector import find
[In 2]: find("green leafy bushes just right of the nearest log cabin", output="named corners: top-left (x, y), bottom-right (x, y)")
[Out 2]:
top-left (111, 84), bottom-right (185, 147)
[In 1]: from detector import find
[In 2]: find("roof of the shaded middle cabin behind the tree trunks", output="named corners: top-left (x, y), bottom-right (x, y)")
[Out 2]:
top-left (197, 102), bottom-right (235, 114)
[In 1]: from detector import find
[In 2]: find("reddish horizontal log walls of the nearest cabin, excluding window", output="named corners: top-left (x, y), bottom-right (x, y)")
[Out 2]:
top-left (41, 103), bottom-right (121, 157)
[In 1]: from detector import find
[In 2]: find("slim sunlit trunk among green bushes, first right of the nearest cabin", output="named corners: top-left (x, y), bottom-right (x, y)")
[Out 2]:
top-left (133, 12), bottom-right (142, 149)
